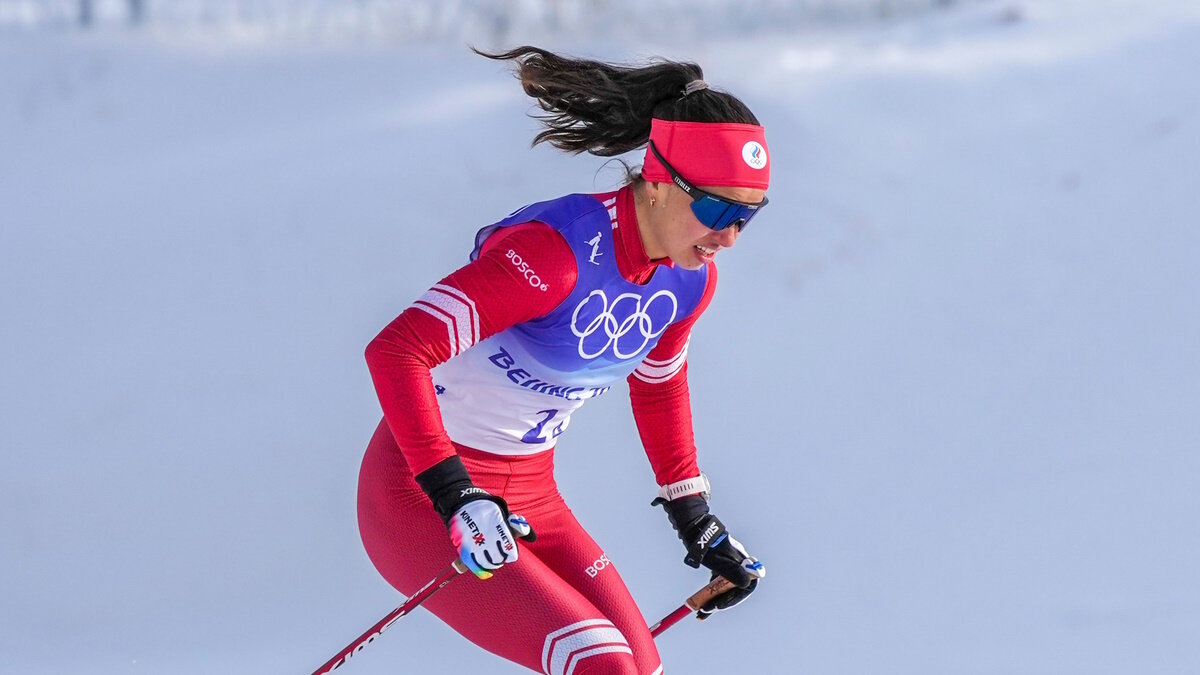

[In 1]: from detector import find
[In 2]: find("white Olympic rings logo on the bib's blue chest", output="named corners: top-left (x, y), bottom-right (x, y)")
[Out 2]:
top-left (571, 288), bottom-right (679, 360)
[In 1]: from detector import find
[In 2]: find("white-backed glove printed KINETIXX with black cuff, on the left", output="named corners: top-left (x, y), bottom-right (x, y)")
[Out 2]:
top-left (416, 455), bottom-right (538, 579)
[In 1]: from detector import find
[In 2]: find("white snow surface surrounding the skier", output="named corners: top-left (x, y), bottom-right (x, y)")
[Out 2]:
top-left (0, 0), bottom-right (1200, 675)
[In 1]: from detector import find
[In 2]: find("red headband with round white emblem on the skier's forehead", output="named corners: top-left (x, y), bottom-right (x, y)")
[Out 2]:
top-left (642, 119), bottom-right (770, 190)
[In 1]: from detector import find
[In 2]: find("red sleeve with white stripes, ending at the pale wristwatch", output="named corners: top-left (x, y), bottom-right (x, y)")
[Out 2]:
top-left (629, 263), bottom-right (716, 485)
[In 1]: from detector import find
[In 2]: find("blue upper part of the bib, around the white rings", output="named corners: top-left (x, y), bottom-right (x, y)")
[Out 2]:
top-left (472, 195), bottom-right (708, 387)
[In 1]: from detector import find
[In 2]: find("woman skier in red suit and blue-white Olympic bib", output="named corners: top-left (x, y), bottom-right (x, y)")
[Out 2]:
top-left (359, 47), bottom-right (770, 675)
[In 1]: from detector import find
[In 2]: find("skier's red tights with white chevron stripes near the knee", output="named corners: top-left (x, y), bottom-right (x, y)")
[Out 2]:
top-left (359, 423), bottom-right (662, 675)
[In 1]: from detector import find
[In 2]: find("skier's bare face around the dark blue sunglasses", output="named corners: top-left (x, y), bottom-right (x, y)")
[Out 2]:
top-left (647, 183), bottom-right (766, 269)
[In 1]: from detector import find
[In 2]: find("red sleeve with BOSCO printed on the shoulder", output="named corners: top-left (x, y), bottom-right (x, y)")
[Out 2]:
top-left (366, 222), bottom-right (578, 474)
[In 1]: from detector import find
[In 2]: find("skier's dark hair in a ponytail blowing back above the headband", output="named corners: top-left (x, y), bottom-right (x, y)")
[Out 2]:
top-left (472, 46), bottom-right (758, 163)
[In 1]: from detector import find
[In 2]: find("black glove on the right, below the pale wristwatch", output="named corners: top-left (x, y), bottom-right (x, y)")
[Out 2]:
top-left (652, 495), bottom-right (767, 619)
